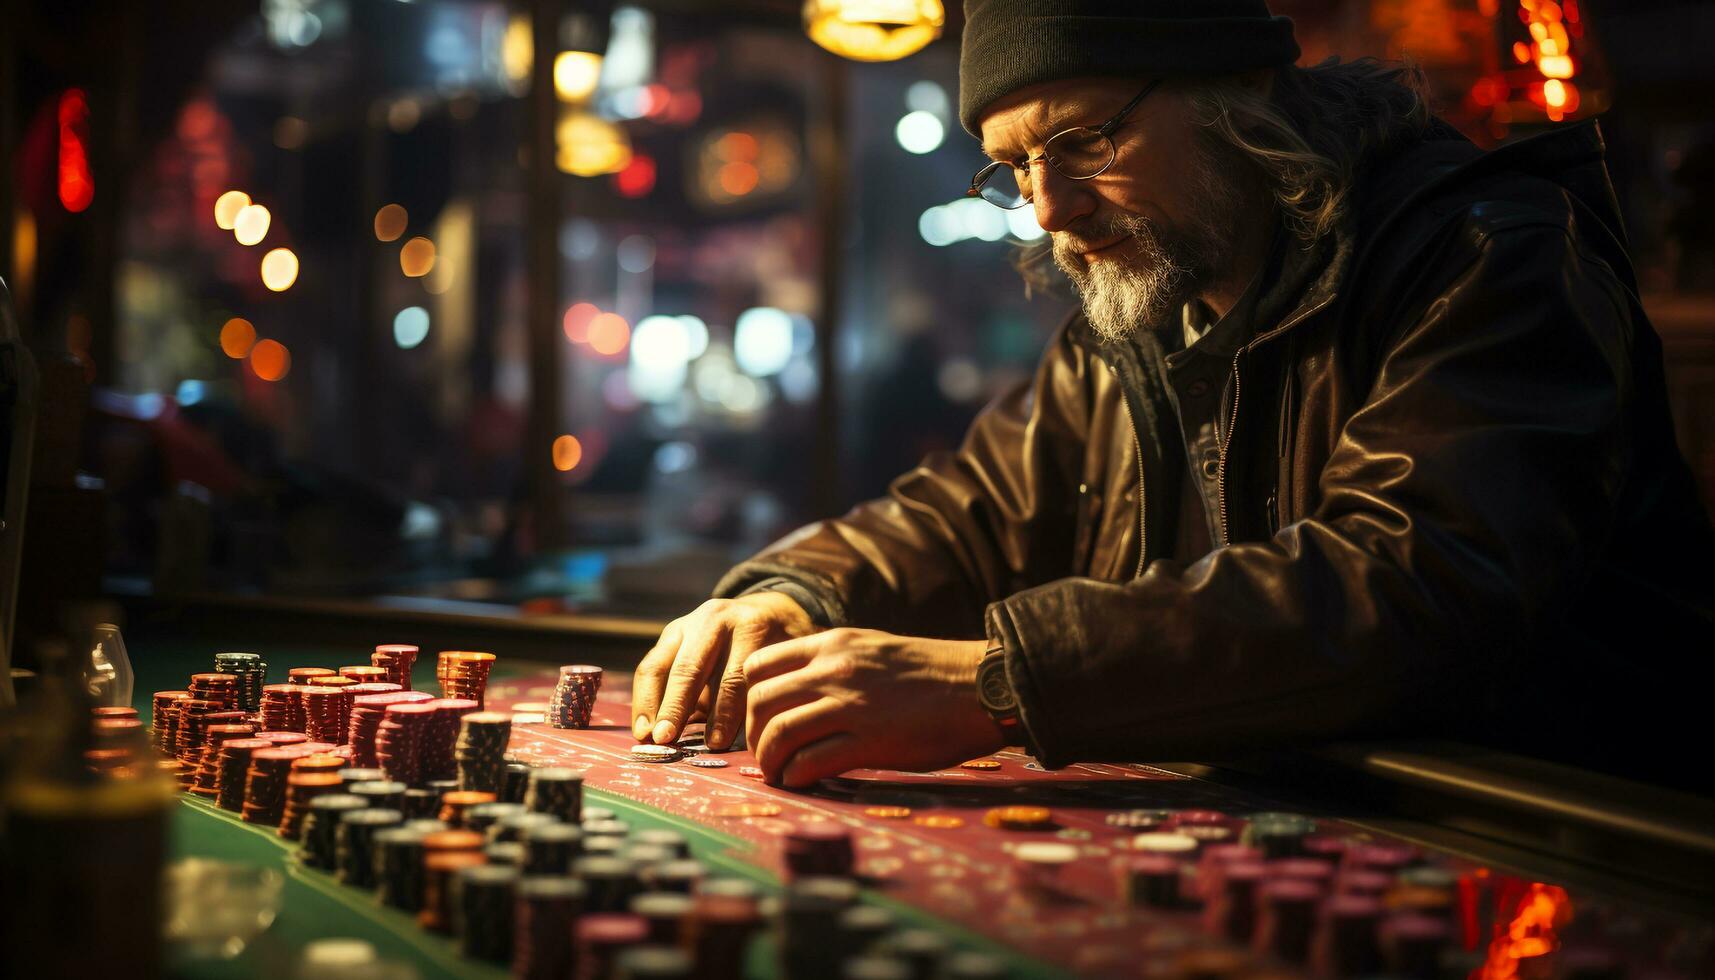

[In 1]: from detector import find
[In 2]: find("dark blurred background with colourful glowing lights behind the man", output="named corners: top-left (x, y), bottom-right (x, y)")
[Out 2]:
top-left (0, 0), bottom-right (1715, 655)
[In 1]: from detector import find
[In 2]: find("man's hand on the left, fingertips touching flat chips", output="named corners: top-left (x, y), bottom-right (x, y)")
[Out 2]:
top-left (631, 592), bottom-right (820, 748)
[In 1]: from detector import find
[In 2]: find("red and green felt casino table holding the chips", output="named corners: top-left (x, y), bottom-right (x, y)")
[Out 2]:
top-left (134, 637), bottom-right (1715, 977)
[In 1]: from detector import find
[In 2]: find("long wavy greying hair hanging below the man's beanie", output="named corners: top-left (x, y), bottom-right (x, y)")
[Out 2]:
top-left (1014, 58), bottom-right (1430, 292)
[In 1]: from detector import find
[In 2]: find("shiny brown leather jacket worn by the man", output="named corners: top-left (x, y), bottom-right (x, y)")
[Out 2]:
top-left (717, 124), bottom-right (1715, 786)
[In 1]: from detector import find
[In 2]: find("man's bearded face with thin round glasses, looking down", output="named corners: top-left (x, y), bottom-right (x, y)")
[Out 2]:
top-left (981, 79), bottom-right (1243, 340)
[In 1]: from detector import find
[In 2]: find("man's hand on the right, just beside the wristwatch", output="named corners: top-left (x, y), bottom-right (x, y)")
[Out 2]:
top-left (744, 628), bottom-right (1005, 788)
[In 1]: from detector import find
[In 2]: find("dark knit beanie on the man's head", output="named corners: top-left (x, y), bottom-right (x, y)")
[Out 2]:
top-left (959, 0), bottom-right (1298, 136)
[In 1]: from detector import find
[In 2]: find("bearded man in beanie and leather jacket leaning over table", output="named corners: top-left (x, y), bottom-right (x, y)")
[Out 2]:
top-left (635, 0), bottom-right (1715, 786)
